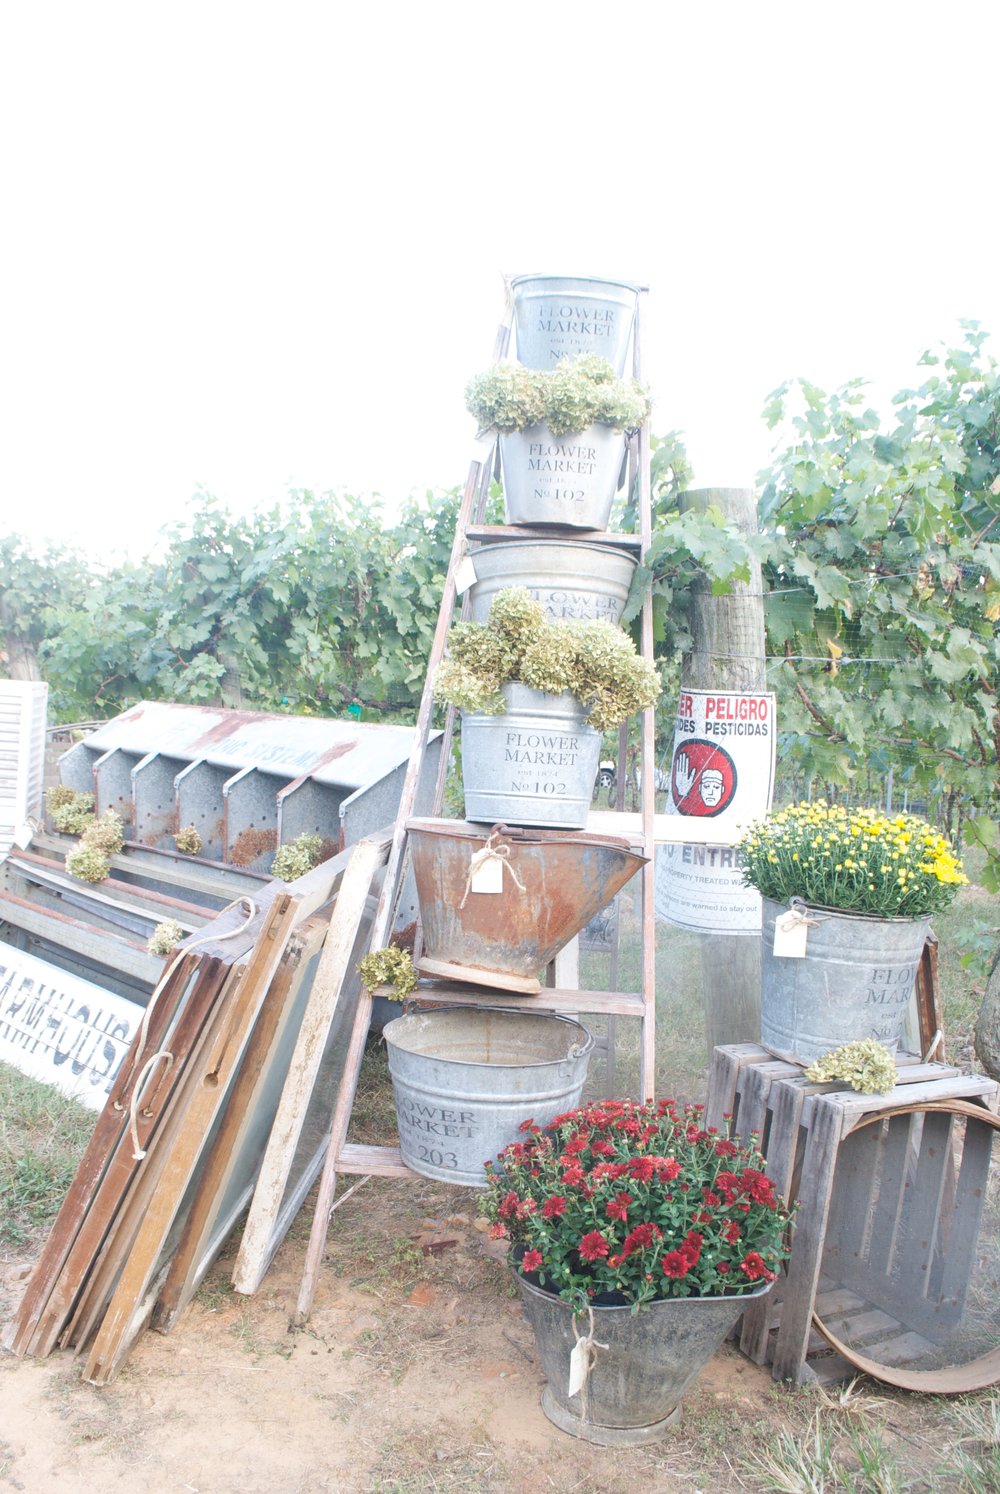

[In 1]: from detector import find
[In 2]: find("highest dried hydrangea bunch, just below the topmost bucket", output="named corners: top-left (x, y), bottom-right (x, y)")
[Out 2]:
top-left (465, 353), bottom-right (650, 436)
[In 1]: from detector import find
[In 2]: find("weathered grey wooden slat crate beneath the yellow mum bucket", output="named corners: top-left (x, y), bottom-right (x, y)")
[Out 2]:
top-left (706, 1043), bottom-right (997, 1382)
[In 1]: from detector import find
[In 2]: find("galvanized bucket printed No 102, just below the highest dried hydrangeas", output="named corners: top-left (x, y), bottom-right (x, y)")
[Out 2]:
top-left (499, 426), bottom-right (625, 529)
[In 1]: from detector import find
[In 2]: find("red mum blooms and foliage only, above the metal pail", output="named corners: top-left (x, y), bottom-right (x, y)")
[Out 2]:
top-left (480, 1100), bottom-right (791, 1309)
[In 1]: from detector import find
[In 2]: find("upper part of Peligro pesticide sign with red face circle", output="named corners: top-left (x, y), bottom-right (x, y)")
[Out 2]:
top-left (667, 690), bottom-right (774, 846)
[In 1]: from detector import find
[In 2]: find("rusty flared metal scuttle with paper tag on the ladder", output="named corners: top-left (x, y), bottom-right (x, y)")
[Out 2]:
top-left (407, 820), bottom-right (646, 995)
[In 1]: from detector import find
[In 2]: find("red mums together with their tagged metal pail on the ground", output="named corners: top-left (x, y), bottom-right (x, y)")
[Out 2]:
top-left (480, 1100), bottom-right (791, 1445)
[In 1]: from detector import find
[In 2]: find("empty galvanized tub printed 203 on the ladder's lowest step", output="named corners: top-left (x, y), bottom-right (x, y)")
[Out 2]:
top-left (383, 1007), bottom-right (593, 1188)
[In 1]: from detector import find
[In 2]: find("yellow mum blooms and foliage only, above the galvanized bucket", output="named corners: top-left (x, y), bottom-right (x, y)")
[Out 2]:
top-left (738, 799), bottom-right (969, 919)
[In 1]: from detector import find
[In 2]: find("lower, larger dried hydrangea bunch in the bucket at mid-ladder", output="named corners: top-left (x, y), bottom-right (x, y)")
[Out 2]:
top-left (433, 587), bottom-right (661, 732)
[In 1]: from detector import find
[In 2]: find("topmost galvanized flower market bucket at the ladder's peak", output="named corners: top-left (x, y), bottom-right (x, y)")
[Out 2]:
top-left (511, 275), bottom-right (638, 378)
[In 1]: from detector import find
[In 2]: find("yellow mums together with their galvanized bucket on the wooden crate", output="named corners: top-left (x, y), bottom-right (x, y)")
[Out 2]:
top-left (738, 799), bottom-right (969, 1064)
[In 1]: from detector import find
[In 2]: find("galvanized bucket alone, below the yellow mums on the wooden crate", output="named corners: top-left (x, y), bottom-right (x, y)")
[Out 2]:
top-left (761, 898), bottom-right (930, 1064)
